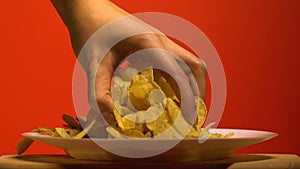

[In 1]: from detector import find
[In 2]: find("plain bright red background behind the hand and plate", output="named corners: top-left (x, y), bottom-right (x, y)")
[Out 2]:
top-left (0, 0), bottom-right (300, 155)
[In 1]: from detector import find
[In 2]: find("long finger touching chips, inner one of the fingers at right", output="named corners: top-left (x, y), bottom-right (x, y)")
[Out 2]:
top-left (120, 34), bottom-right (200, 124)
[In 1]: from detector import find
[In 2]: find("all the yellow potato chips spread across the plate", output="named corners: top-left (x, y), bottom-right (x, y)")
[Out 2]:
top-left (16, 67), bottom-right (233, 154)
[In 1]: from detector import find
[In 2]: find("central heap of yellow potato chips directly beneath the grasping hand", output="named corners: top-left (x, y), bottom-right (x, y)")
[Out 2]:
top-left (107, 67), bottom-right (207, 138)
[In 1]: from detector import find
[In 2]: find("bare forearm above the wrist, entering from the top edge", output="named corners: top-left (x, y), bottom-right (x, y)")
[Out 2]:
top-left (51, 0), bottom-right (128, 54)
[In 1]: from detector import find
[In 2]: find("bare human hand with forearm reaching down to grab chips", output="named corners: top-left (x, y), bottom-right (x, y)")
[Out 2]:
top-left (52, 0), bottom-right (206, 123)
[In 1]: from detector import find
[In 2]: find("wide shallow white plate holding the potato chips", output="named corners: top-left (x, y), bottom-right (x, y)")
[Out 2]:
top-left (22, 129), bottom-right (278, 161)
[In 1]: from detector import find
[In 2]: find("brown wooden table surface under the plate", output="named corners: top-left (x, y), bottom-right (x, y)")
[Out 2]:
top-left (0, 154), bottom-right (300, 169)
